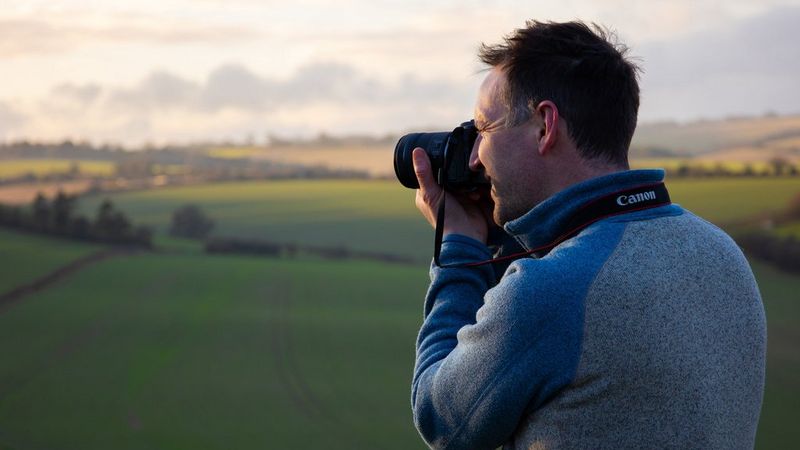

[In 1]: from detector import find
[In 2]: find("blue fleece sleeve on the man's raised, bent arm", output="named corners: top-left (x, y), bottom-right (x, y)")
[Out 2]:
top-left (411, 236), bottom-right (588, 449)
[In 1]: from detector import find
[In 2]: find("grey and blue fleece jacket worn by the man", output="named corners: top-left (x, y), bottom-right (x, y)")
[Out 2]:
top-left (411, 170), bottom-right (766, 449)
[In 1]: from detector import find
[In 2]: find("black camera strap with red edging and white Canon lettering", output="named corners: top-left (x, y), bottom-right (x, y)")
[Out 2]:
top-left (433, 182), bottom-right (672, 268)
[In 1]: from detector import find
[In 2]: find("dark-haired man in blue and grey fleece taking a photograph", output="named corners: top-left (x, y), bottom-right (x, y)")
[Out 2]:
top-left (412, 22), bottom-right (766, 449)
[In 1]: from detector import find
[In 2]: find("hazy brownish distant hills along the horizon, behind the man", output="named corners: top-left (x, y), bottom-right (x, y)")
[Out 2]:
top-left (6, 115), bottom-right (800, 178)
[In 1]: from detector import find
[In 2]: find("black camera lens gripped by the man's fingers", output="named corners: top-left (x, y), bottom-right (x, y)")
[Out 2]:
top-left (394, 131), bottom-right (451, 189)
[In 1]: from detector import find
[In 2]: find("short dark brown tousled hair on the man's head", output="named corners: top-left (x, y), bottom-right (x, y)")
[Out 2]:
top-left (478, 21), bottom-right (639, 167)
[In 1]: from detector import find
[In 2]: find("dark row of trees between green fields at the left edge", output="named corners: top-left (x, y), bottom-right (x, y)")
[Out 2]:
top-left (0, 191), bottom-right (152, 248)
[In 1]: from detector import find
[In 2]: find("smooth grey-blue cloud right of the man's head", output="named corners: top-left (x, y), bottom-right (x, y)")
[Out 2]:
top-left (637, 7), bottom-right (800, 120)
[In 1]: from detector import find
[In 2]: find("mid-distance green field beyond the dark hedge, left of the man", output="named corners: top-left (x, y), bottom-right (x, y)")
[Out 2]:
top-left (80, 181), bottom-right (433, 262)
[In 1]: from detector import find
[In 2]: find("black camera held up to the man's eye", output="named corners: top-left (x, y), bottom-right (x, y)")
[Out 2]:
top-left (394, 120), bottom-right (489, 192)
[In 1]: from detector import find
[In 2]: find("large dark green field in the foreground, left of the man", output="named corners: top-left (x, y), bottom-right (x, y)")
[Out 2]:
top-left (0, 246), bottom-right (427, 449)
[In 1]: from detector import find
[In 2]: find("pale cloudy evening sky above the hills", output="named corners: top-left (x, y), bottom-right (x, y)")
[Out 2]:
top-left (0, 0), bottom-right (800, 146)
